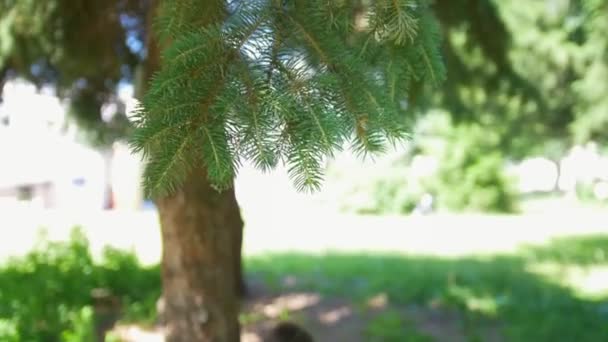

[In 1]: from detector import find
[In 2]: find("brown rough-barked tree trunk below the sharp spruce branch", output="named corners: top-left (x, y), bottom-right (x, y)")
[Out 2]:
top-left (157, 170), bottom-right (242, 342)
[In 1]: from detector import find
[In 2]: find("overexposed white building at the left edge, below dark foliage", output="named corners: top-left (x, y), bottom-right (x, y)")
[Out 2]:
top-left (0, 128), bottom-right (104, 208)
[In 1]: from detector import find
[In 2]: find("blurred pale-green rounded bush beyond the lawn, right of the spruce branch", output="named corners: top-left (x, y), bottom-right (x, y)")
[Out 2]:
top-left (341, 118), bottom-right (518, 214)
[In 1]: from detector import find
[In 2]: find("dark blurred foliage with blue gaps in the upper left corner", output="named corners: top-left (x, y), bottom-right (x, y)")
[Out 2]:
top-left (0, 0), bottom-right (149, 144)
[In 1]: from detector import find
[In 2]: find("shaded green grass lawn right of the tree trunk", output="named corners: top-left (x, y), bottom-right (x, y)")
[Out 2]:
top-left (247, 236), bottom-right (608, 342)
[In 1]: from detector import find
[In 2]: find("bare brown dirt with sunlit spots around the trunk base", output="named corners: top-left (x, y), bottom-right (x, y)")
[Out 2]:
top-left (112, 285), bottom-right (503, 342)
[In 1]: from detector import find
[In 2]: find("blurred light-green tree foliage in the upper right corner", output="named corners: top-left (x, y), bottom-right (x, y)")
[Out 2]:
top-left (446, 0), bottom-right (608, 158)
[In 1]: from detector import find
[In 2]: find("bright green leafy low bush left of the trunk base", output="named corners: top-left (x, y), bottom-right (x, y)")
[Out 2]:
top-left (0, 229), bottom-right (160, 341)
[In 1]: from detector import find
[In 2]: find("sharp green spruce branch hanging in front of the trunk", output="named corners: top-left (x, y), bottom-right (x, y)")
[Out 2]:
top-left (131, 0), bottom-right (445, 194)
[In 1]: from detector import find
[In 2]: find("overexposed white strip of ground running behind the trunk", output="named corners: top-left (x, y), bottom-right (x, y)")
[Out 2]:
top-left (0, 203), bottom-right (608, 263)
